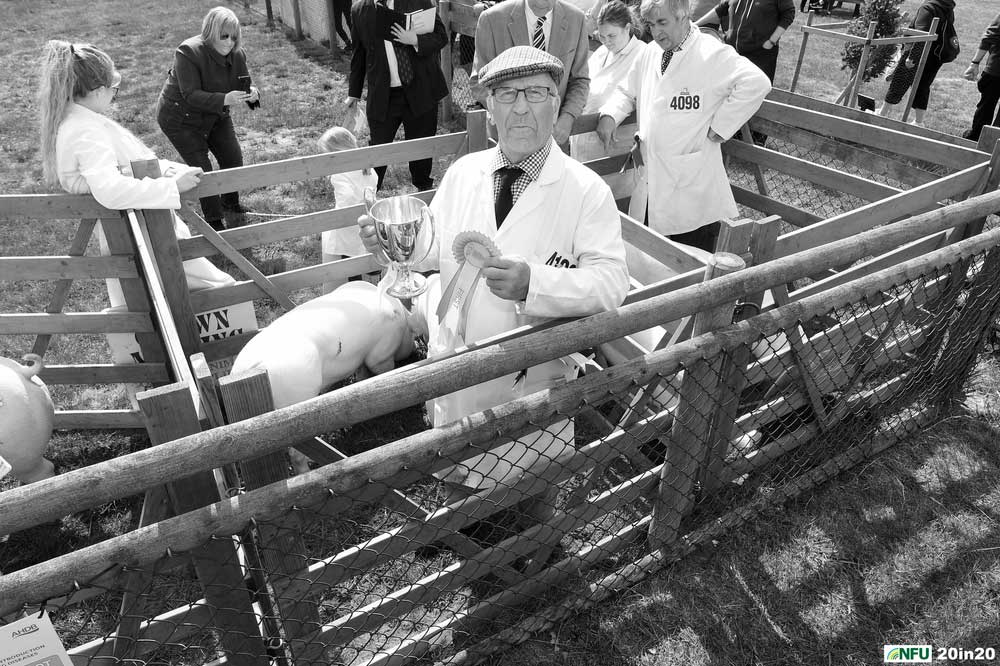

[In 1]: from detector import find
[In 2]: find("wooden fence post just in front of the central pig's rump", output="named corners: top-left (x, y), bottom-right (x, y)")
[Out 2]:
top-left (219, 370), bottom-right (322, 648)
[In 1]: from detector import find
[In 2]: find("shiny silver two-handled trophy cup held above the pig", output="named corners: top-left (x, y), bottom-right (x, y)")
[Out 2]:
top-left (365, 187), bottom-right (434, 298)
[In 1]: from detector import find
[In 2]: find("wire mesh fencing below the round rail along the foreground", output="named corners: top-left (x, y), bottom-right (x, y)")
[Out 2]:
top-left (0, 218), bottom-right (1000, 665)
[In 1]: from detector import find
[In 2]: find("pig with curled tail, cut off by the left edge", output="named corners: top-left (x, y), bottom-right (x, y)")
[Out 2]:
top-left (0, 354), bottom-right (55, 483)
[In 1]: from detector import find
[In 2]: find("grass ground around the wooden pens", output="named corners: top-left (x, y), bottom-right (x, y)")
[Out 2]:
top-left (0, 0), bottom-right (1000, 666)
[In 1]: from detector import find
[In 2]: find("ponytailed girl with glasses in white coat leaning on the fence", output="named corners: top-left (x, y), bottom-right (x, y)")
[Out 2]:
top-left (38, 40), bottom-right (235, 307)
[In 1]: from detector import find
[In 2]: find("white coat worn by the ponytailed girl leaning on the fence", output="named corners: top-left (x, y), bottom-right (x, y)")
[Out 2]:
top-left (56, 103), bottom-right (235, 307)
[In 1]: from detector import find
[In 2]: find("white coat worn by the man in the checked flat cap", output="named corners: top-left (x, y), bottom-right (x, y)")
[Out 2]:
top-left (419, 137), bottom-right (628, 487)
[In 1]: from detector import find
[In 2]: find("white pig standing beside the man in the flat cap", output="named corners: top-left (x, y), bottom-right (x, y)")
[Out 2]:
top-left (230, 282), bottom-right (427, 473)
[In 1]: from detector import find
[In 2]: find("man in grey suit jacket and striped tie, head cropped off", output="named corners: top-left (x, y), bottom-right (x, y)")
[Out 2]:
top-left (469, 0), bottom-right (590, 145)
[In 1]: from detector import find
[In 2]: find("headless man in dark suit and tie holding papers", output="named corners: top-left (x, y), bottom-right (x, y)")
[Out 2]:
top-left (346, 0), bottom-right (448, 191)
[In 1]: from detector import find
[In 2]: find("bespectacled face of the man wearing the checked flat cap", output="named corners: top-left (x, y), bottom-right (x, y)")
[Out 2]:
top-left (486, 74), bottom-right (559, 164)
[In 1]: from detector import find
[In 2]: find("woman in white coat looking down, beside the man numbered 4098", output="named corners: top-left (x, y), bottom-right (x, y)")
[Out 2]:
top-left (569, 0), bottom-right (643, 199)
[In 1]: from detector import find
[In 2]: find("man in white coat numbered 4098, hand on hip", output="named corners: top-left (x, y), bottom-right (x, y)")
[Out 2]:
top-left (597, 0), bottom-right (771, 252)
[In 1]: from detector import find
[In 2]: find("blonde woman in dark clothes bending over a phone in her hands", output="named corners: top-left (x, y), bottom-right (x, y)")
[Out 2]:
top-left (156, 7), bottom-right (260, 230)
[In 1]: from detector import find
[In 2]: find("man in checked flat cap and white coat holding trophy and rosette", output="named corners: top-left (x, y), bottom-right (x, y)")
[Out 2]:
top-left (359, 46), bottom-right (628, 528)
